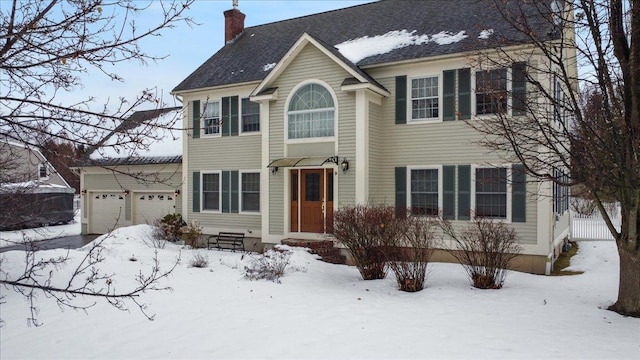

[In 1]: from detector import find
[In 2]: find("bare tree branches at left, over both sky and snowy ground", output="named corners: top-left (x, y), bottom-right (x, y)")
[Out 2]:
top-left (0, 0), bottom-right (193, 324)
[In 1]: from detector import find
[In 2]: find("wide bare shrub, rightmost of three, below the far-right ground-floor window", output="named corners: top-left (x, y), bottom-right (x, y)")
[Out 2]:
top-left (441, 217), bottom-right (522, 289)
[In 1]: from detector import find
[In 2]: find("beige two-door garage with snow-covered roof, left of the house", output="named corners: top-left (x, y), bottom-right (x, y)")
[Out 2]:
top-left (75, 108), bottom-right (183, 234)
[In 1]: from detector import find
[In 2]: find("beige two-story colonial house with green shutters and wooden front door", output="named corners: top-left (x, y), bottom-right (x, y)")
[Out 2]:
top-left (173, 0), bottom-right (575, 273)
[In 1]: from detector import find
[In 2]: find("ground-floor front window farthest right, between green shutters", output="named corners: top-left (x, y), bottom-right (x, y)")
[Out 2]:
top-left (475, 167), bottom-right (508, 219)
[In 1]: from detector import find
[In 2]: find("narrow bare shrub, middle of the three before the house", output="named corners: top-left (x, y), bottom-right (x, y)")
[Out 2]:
top-left (387, 216), bottom-right (435, 292)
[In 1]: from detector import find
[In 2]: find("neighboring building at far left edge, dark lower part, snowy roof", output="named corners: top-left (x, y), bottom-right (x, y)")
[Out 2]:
top-left (0, 140), bottom-right (75, 230)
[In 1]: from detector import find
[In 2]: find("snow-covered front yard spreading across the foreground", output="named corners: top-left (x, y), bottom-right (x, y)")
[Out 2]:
top-left (0, 225), bottom-right (640, 359)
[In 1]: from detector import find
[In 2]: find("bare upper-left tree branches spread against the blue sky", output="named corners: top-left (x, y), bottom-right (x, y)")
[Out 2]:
top-left (0, 0), bottom-right (193, 150)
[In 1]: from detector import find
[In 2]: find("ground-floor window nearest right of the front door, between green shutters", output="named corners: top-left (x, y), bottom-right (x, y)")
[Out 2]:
top-left (411, 169), bottom-right (439, 216)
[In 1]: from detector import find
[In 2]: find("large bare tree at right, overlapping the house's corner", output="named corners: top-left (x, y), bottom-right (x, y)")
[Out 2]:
top-left (469, 0), bottom-right (640, 316)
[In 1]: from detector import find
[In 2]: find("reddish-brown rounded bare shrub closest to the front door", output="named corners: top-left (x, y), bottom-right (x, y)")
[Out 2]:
top-left (333, 205), bottom-right (398, 280)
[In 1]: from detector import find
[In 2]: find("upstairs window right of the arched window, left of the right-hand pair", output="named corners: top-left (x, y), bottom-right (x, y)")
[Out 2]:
top-left (411, 76), bottom-right (440, 120)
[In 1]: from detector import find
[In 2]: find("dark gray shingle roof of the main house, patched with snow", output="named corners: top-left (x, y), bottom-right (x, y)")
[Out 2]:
top-left (173, 0), bottom-right (551, 92)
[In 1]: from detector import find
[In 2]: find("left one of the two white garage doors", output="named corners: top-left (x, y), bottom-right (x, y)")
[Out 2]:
top-left (89, 192), bottom-right (125, 234)
